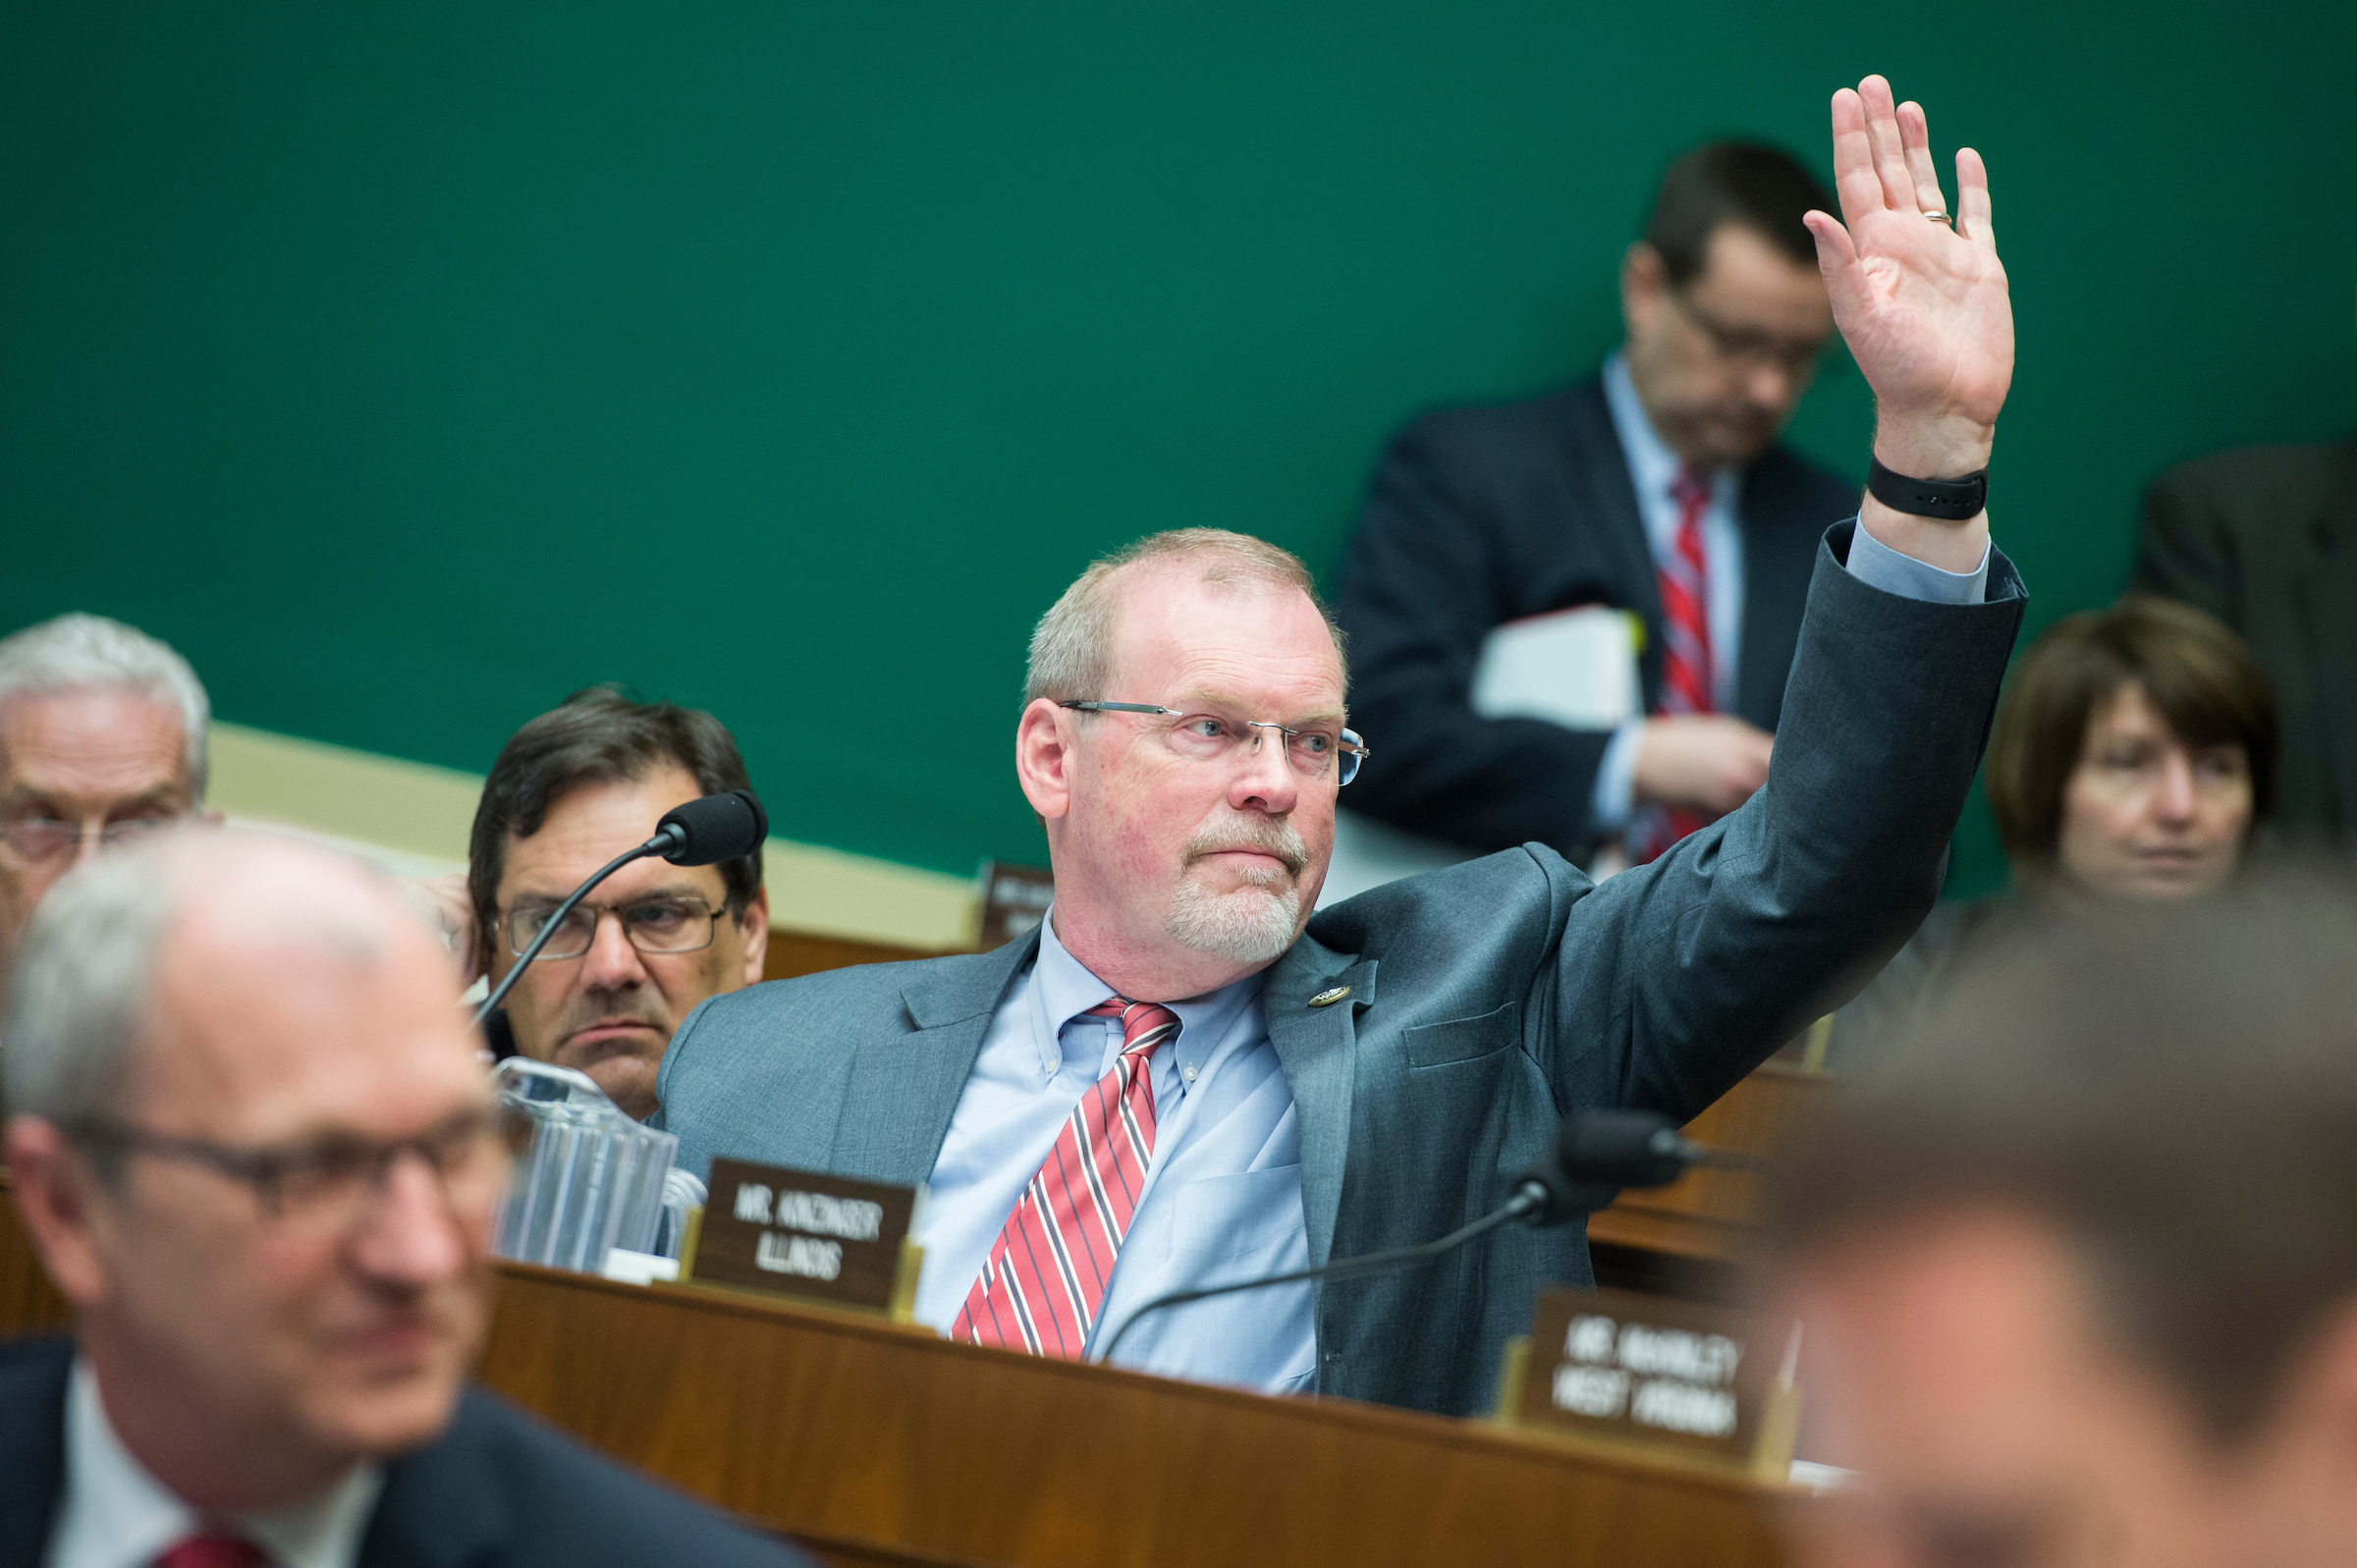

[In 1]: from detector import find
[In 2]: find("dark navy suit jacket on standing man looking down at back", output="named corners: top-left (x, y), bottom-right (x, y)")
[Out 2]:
top-left (1334, 377), bottom-right (1860, 861)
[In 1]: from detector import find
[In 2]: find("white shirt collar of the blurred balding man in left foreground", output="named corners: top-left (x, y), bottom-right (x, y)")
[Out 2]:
top-left (49, 1356), bottom-right (384, 1568)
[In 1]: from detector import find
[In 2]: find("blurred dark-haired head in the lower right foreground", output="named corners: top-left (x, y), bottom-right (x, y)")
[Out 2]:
top-left (1781, 887), bottom-right (2357, 1568)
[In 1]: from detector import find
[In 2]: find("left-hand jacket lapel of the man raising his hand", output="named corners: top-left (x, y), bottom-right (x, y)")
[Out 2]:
top-left (827, 932), bottom-right (1039, 1186)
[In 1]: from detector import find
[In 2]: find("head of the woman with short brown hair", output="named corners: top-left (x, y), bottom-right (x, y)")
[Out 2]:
top-left (1987, 597), bottom-right (2276, 898)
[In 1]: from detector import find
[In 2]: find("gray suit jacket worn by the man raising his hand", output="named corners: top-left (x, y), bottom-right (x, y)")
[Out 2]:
top-left (660, 523), bottom-right (2022, 1415)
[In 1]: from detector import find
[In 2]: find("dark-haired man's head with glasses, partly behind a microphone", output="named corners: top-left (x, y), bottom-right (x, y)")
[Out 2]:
top-left (466, 686), bottom-right (768, 1117)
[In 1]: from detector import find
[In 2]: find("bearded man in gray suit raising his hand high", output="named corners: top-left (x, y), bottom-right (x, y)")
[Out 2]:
top-left (660, 78), bottom-right (2022, 1413)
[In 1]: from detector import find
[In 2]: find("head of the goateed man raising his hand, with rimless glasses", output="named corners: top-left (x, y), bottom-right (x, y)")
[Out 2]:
top-left (1015, 528), bottom-right (1345, 1002)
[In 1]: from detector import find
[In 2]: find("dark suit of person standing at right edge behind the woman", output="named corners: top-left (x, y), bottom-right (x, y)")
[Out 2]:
top-left (2133, 301), bottom-right (2357, 841)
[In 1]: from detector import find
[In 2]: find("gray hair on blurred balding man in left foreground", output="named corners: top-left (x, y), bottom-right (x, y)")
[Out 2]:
top-left (0, 835), bottom-right (187, 1125)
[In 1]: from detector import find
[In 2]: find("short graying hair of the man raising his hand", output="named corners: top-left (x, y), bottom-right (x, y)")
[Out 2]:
top-left (1023, 528), bottom-right (1350, 707)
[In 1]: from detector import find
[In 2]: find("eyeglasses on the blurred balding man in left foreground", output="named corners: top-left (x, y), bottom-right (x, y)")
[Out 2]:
top-left (64, 1108), bottom-right (514, 1235)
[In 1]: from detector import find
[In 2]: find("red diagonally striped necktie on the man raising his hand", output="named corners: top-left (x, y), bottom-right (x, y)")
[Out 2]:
top-left (950, 998), bottom-right (1178, 1361)
